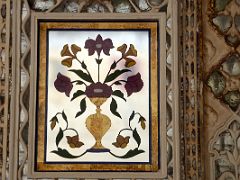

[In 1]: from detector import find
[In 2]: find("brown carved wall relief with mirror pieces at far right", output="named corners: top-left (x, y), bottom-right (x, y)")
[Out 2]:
top-left (202, 0), bottom-right (240, 179)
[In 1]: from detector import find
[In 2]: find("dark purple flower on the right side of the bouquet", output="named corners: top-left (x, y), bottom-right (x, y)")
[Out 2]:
top-left (125, 73), bottom-right (143, 96)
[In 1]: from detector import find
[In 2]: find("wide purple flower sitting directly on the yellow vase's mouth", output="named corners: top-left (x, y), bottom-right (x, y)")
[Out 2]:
top-left (85, 82), bottom-right (112, 98)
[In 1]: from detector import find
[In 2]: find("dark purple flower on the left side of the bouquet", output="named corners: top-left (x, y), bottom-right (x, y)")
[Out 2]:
top-left (54, 73), bottom-right (73, 97)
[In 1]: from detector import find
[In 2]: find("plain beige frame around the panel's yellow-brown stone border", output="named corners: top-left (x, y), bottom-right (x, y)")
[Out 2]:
top-left (28, 13), bottom-right (167, 178)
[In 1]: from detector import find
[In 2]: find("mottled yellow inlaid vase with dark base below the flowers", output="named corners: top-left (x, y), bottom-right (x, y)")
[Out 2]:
top-left (86, 97), bottom-right (111, 152)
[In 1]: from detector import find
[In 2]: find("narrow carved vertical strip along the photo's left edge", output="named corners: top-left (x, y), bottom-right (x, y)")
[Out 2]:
top-left (0, 1), bottom-right (11, 179)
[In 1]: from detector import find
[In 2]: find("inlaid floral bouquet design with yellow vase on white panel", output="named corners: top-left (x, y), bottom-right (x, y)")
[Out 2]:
top-left (50, 34), bottom-right (147, 158)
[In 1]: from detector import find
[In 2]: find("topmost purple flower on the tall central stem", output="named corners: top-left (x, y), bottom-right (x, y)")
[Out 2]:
top-left (84, 34), bottom-right (114, 56)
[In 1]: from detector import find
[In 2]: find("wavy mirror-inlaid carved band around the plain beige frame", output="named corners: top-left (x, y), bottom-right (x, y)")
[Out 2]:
top-left (5, 0), bottom-right (182, 179)
